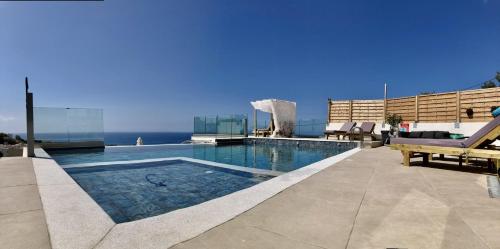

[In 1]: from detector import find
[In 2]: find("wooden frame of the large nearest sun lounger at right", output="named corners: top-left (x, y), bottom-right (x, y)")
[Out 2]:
top-left (390, 126), bottom-right (500, 174)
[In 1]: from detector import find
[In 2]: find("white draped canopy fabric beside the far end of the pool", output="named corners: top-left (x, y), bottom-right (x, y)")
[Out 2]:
top-left (250, 99), bottom-right (297, 137)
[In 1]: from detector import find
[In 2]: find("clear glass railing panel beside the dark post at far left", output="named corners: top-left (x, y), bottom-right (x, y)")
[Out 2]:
top-left (33, 107), bottom-right (104, 142)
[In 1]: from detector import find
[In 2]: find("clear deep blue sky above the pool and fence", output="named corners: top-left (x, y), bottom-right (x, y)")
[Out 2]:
top-left (0, 0), bottom-right (500, 132)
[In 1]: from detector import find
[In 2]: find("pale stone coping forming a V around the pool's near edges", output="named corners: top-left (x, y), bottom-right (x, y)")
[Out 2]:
top-left (33, 147), bottom-right (361, 249)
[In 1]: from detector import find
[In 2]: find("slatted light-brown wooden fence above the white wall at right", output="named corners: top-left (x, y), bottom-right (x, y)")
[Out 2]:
top-left (328, 87), bottom-right (500, 123)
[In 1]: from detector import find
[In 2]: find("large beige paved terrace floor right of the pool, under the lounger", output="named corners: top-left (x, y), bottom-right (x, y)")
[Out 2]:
top-left (174, 148), bottom-right (500, 249)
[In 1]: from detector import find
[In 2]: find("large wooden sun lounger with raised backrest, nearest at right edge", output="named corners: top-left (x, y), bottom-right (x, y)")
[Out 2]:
top-left (391, 116), bottom-right (500, 172)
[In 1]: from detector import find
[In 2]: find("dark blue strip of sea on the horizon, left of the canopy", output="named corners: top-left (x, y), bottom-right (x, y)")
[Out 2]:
top-left (11, 132), bottom-right (192, 145)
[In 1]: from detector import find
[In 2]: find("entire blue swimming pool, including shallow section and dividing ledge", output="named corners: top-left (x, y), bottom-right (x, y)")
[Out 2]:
top-left (43, 139), bottom-right (358, 223)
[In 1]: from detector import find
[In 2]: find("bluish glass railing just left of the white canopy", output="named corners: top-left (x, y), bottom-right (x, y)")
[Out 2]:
top-left (193, 114), bottom-right (248, 136)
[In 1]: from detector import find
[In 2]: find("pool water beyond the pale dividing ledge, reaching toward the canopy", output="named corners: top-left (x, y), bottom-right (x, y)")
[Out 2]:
top-left (49, 142), bottom-right (356, 172)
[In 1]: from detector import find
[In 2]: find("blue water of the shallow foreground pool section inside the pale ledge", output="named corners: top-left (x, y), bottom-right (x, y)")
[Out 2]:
top-left (65, 160), bottom-right (272, 223)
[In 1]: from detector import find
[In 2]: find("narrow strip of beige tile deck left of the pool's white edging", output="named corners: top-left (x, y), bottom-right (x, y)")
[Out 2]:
top-left (0, 157), bottom-right (51, 249)
